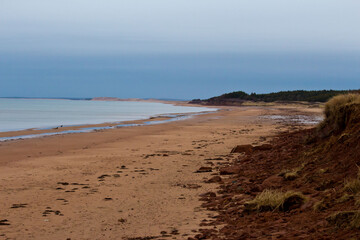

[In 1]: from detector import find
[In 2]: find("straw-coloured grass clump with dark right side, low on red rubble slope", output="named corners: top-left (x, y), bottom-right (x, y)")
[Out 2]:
top-left (245, 189), bottom-right (306, 212)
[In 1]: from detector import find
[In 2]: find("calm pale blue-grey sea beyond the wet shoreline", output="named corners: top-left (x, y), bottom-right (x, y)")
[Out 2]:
top-left (0, 99), bottom-right (214, 132)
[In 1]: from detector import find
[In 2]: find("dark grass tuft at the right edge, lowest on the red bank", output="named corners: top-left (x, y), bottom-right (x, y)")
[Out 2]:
top-left (326, 211), bottom-right (360, 228)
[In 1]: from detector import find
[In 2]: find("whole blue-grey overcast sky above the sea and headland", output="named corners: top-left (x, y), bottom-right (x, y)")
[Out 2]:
top-left (0, 0), bottom-right (360, 99)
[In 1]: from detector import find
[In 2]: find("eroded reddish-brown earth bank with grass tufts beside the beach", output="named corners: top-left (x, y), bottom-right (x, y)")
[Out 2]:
top-left (196, 96), bottom-right (360, 239)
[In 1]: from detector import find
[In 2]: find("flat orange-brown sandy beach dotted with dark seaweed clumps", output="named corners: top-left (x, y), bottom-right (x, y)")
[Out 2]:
top-left (0, 105), bottom-right (321, 239)
